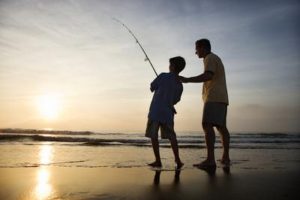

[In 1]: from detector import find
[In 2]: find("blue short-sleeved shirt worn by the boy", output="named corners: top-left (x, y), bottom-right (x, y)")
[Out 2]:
top-left (148, 72), bottom-right (183, 124)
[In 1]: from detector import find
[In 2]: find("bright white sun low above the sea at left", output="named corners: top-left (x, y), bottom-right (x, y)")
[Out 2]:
top-left (37, 94), bottom-right (60, 120)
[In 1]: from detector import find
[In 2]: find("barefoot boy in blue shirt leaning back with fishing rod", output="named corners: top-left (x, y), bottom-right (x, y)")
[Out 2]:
top-left (146, 56), bottom-right (185, 169)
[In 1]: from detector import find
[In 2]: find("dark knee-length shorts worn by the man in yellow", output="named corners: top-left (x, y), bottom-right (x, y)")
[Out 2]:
top-left (202, 102), bottom-right (227, 127)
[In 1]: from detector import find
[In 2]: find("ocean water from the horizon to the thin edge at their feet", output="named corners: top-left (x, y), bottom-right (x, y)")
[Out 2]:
top-left (0, 131), bottom-right (300, 168)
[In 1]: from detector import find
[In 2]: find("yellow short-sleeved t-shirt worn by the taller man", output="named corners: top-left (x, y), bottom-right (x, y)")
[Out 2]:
top-left (202, 53), bottom-right (229, 104)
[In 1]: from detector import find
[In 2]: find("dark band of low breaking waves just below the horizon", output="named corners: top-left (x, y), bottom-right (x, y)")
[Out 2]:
top-left (0, 133), bottom-right (300, 149)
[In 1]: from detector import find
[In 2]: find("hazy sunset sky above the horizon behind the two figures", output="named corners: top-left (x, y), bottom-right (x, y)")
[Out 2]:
top-left (0, 0), bottom-right (300, 132)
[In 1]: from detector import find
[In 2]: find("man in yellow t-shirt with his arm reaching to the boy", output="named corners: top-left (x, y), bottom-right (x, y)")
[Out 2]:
top-left (180, 39), bottom-right (230, 169)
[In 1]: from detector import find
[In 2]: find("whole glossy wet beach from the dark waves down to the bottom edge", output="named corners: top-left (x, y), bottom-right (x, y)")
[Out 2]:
top-left (0, 135), bottom-right (300, 200)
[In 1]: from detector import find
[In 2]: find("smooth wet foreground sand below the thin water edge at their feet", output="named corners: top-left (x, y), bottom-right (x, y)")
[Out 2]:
top-left (0, 166), bottom-right (300, 200)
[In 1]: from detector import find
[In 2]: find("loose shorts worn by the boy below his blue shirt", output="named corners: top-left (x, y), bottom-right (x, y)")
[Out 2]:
top-left (145, 119), bottom-right (176, 139)
